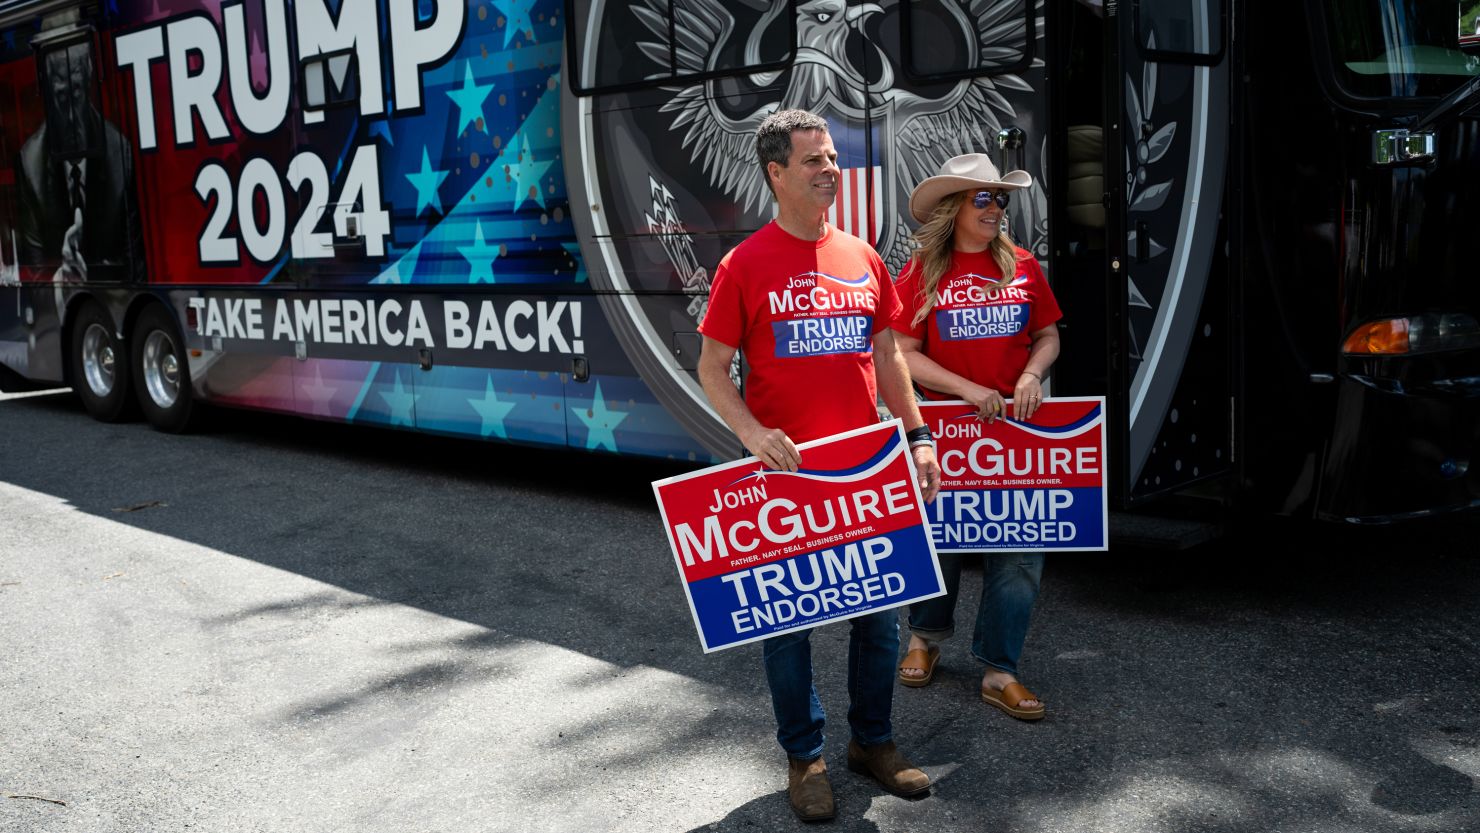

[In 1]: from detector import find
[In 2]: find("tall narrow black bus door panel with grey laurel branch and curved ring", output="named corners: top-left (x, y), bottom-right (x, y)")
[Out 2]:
top-left (1104, 0), bottom-right (1237, 506)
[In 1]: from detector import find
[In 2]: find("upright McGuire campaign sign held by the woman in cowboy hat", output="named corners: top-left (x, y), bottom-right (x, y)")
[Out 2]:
top-left (921, 397), bottom-right (1110, 552)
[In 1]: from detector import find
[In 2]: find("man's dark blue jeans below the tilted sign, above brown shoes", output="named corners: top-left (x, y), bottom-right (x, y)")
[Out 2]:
top-left (761, 610), bottom-right (900, 761)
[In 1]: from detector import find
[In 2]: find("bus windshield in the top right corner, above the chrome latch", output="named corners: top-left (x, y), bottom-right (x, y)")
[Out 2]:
top-left (1326, 0), bottom-right (1480, 98)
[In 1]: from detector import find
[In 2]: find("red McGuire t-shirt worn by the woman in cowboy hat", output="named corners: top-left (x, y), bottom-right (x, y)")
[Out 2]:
top-left (892, 249), bottom-right (1061, 399)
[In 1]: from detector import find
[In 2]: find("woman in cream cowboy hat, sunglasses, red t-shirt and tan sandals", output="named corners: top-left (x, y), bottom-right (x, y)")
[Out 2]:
top-left (894, 154), bottom-right (1060, 721)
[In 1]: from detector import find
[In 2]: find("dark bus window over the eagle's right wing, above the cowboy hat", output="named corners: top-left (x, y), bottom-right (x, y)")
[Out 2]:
top-left (900, 0), bottom-right (1042, 81)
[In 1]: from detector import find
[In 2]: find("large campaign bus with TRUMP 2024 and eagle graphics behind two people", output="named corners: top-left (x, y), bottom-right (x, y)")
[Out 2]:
top-left (0, 0), bottom-right (1480, 522)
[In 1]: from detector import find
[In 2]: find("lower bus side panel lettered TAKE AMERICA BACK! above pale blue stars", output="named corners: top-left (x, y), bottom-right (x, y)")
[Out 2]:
top-left (169, 287), bottom-right (710, 462)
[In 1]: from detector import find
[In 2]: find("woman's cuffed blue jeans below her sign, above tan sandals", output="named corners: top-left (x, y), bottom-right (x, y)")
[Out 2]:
top-left (910, 552), bottom-right (1043, 676)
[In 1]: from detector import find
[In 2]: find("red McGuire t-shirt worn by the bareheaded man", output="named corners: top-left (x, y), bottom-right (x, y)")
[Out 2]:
top-left (699, 222), bottom-right (900, 442)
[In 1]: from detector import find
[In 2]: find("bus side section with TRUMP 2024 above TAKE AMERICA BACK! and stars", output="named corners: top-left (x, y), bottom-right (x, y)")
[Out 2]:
top-left (83, 0), bottom-right (704, 459)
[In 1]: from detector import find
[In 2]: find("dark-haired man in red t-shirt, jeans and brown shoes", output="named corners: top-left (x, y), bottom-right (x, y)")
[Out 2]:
top-left (699, 109), bottom-right (940, 821)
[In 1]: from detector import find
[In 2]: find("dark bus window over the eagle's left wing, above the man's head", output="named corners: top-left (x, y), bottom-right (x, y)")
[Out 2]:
top-left (565, 0), bottom-right (799, 96)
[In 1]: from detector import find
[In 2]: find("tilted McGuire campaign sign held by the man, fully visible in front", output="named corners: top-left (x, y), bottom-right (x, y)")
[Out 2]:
top-left (653, 420), bottom-right (946, 654)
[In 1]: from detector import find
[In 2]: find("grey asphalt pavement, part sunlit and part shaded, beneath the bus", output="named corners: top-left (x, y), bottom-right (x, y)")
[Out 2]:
top-left (0, 394), bottom-right (1480, 833)
